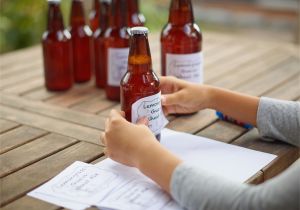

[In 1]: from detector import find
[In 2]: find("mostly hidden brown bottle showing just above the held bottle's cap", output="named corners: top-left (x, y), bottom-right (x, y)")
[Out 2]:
top-left (127, 0), bottom-right (145, 27)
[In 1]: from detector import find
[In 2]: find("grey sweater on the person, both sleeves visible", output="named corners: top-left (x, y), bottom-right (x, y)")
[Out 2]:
top-left (171, 98), bottom-right (300, 210)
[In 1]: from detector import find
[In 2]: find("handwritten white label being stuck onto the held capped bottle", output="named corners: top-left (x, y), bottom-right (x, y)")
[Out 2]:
top-left (131, 92), bottom-right (168, 135)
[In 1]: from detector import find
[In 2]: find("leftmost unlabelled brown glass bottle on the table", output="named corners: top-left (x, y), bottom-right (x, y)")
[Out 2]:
top-left (42, 0), bottom-right (73, 90)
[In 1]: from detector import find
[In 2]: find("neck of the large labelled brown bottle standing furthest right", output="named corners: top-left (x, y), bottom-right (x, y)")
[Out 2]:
top-left (169, 0), bottom-right (194, 25)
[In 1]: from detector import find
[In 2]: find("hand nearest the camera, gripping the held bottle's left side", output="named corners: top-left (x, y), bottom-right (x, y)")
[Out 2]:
top-left (101, 110), bottom-right (160, 167)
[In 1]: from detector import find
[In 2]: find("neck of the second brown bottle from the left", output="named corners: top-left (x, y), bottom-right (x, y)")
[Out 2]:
top-left (70, 0), bottom-right (85, 27)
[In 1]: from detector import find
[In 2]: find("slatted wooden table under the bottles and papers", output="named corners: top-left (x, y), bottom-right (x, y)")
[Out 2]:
top-left (0, 33), bottom-right (300, 210)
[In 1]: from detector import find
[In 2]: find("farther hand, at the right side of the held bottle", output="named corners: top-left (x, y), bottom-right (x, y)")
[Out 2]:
top-left (160, 76), bottom-right (209, 115)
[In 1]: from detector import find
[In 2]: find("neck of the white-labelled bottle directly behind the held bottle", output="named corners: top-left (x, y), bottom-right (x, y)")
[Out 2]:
top-left (110, 0), bottom-right (127, 28)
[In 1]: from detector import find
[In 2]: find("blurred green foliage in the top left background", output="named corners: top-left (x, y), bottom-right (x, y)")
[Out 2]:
top-left (0, 0), bottom-right (70, 53)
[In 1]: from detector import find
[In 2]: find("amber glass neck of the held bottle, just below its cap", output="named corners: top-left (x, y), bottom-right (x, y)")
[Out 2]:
top-left (128, 34), bottom-right (152, 74)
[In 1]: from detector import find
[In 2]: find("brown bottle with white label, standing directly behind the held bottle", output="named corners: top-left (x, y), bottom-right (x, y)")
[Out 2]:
top-left (103, 0), bottom-right (129, 101)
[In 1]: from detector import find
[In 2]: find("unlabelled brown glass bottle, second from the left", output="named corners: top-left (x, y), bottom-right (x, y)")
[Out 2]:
top-left (70, 0), bottom-right (94, 82)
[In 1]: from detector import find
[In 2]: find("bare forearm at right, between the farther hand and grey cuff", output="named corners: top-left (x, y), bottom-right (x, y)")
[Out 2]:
top-left (207, 86), bottom-right (259, 126)
